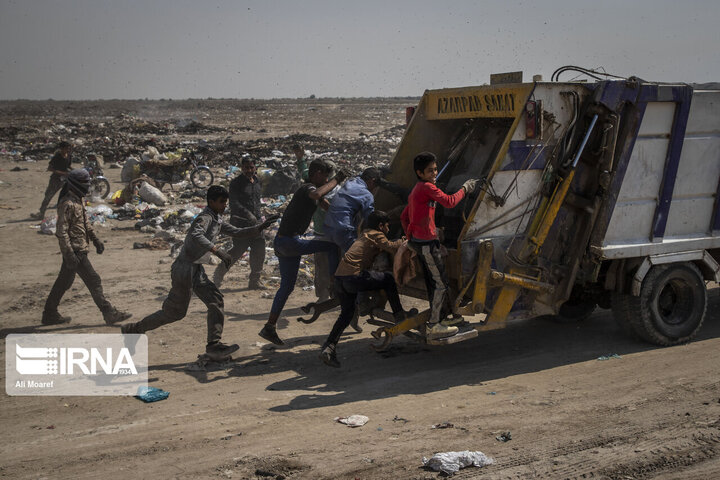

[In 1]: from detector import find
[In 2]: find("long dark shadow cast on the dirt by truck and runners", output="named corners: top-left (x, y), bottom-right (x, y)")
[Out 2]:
top-left (151, 296), bottom-right (720, 412)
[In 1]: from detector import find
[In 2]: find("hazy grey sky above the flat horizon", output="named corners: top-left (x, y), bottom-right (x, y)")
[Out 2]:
top-left (0, 0), bottom-right (720, 100)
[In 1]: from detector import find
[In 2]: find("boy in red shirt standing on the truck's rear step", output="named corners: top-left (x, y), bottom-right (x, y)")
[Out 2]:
top-left (400, 152), bottom-right (477, 338)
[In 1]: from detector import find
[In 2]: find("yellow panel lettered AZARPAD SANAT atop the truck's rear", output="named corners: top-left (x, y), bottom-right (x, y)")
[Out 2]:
top-left (425, 84), bottom-right (533, 120)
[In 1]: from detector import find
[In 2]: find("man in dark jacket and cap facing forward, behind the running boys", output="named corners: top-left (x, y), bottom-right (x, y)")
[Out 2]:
top-left (213, 157), bottom-right (266, 290)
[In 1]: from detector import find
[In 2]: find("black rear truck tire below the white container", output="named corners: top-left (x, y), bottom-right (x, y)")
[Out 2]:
top-left (622, 263), bottom-right (707, 345)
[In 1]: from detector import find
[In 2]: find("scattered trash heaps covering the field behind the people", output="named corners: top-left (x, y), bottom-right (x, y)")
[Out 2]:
top-left (5, 102), bottom-right (405, 284)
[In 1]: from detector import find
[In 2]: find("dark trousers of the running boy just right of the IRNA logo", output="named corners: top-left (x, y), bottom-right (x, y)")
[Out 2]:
top-left (135, 259), bottom-right (225, 343)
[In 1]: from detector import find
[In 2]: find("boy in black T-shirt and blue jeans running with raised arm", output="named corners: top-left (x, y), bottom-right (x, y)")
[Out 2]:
top-left (259, 160), bottom-right (345, 345)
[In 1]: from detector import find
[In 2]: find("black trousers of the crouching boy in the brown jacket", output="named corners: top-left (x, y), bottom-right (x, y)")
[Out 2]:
top-left (323, 270), bottom-right (403, 348)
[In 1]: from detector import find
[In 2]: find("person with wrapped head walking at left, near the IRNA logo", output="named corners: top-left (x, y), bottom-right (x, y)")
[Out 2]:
top-left (42, 168), bottom-right (132, 325)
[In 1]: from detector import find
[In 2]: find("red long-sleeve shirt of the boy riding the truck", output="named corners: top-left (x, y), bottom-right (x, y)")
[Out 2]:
top-left (400, 181), bottom-right (465, 240)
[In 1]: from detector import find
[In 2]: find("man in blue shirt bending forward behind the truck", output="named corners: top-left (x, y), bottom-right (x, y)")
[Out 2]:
top-left (324, 167), bottom-right (380, 254)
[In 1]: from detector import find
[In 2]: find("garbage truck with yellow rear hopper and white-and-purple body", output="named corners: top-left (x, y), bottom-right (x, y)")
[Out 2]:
top-left (358, 68), bottom-right (720, 350)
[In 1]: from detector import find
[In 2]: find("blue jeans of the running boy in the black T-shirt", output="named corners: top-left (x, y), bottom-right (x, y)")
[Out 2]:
top-left (270, 235), bottom-right (338, 315)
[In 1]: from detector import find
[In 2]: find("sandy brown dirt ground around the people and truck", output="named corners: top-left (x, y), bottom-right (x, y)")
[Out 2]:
top-left (0, 99), bottom-right (720, 479)
